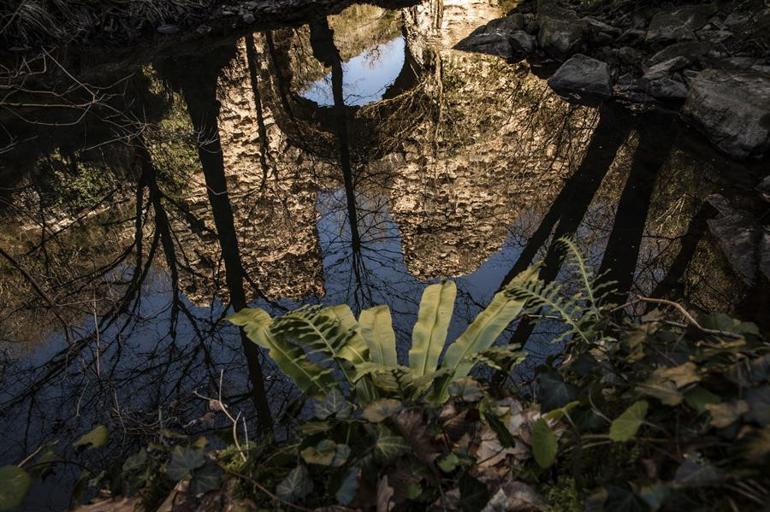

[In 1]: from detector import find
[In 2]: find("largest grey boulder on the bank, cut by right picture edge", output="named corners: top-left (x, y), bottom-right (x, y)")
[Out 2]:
top-left (683, 69), bottom-right (770, 158)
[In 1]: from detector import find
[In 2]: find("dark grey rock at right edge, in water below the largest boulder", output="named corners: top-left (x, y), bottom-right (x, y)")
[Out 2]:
top-left (707, 194), bottom-right (770, 286)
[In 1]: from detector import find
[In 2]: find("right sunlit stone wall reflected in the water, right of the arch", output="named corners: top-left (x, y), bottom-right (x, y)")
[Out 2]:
top-left (382, 2), bottom-right (596, 278)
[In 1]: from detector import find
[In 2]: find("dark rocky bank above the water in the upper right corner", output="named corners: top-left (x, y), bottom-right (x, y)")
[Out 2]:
top-left (457, 0), bottom-right (770, 159)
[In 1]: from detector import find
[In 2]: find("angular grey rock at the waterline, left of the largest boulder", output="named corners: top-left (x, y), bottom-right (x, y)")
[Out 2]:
top-left (548, 54), bottom-right (612, 98)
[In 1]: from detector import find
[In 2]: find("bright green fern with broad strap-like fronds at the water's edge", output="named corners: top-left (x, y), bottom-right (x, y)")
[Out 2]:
top-left (228, 267), bottom-right (538, 403)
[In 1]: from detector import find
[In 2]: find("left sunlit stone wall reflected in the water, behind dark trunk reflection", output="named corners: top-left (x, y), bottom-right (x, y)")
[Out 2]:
top-left (176, 40), bottom-right (323, 302)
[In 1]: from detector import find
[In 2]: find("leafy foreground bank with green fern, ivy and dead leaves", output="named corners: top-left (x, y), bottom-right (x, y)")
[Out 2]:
top-left (84, 242), bottom-right (770, 512)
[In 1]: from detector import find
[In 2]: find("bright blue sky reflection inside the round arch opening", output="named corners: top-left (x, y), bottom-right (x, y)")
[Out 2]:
top-left (301, 36), bottom-right (405, 106)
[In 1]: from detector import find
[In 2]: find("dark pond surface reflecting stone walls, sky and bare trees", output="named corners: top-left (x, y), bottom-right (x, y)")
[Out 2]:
top-left (0, 0), bottom-right (766, 510)
